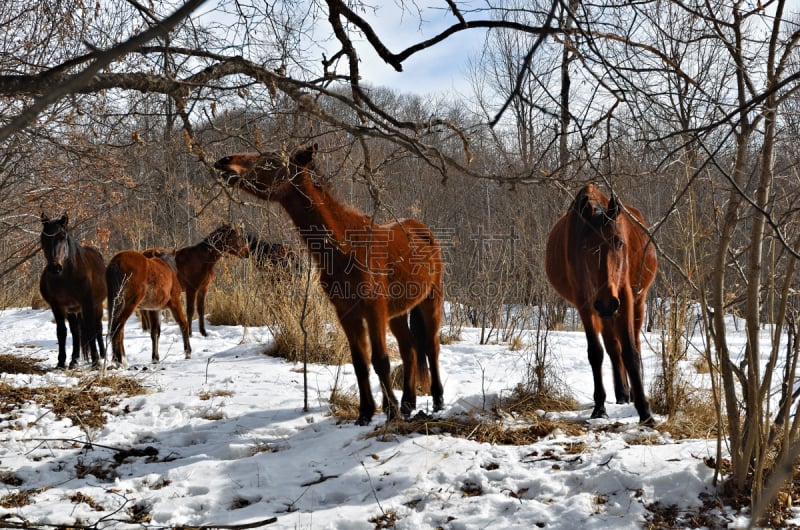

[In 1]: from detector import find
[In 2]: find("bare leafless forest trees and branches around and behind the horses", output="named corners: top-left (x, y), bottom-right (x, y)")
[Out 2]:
top-left (0, 0), bottom-right (800, 520)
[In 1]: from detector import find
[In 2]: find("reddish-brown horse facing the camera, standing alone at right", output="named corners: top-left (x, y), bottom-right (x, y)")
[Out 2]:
top-left (545, 184), bottom-right (657, 425)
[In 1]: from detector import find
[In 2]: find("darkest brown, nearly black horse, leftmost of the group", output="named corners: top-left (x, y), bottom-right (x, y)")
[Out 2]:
top-left (39, 213), bottom-right (106, 368)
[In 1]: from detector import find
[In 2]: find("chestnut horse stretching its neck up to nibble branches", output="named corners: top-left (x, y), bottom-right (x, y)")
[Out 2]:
top-left (215, 145), bottom-right (444, 425)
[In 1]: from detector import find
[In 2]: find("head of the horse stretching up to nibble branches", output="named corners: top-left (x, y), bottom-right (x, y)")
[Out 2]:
top-left (214, 144), bottom-right (324, 201)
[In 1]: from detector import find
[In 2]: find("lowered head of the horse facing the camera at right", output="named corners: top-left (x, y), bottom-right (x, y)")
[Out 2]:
top-left (577, 186), bottom-right (627, 318)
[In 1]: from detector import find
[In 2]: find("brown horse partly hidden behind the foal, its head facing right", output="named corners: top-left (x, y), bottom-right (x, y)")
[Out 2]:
top-left (142, 224), bottom-right (250, 337)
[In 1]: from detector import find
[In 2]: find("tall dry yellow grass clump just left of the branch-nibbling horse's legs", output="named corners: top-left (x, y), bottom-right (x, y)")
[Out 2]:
top-left (206, 262), bottom-right (350, 365)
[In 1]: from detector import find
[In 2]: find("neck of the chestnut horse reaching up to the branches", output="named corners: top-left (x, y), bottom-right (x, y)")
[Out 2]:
top-left (279, 172), bottom-right (372, 250)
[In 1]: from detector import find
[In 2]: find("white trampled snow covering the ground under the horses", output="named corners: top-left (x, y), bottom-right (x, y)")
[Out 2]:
top-left (0, 309), bottom-right (764, 530)
